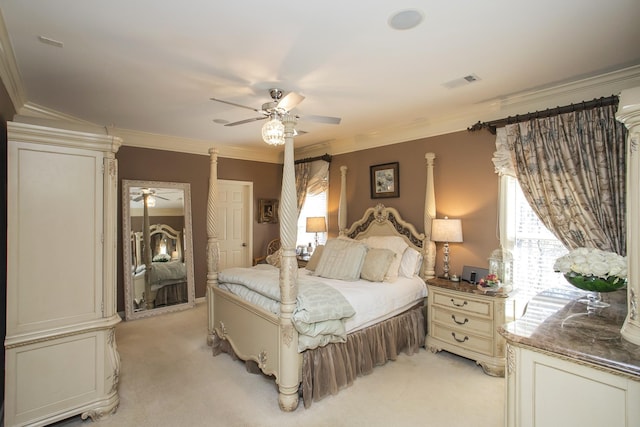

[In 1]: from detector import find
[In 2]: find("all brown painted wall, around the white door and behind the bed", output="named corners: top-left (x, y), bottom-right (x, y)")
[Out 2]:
top-left (116, 131), bottom-right (499, 311)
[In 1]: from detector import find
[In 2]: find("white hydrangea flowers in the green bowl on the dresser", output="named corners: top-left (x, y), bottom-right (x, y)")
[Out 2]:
top-left (553, 248), bottom-right (627, 280)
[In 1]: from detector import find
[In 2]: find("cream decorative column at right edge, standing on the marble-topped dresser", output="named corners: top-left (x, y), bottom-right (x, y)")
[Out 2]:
top-left (616, 87), bottom-right (640, 345)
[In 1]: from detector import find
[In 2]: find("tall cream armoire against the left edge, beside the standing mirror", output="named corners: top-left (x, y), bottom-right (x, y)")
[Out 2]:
top-left (4, 122), bottom-right (121, 426)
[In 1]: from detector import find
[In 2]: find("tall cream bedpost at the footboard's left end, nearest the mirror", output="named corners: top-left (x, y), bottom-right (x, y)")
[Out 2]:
top-left (207, 148), bottom-right (220, 345)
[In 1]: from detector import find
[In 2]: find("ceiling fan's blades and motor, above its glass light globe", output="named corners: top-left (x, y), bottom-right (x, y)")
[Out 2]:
top-left (211, 88), bottom-right (342, 126)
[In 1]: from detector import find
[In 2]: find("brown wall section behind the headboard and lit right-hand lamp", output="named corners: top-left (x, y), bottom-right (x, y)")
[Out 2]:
top-left (328, 131), bottom-right (499, 280)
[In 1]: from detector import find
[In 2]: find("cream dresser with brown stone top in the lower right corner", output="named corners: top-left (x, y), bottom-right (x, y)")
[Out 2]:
top-left (500, 288), bottom-right (640, 427)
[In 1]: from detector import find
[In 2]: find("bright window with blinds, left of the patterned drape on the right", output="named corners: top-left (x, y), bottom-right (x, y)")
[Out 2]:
top-left (502, 175), bottom-right (568, 310)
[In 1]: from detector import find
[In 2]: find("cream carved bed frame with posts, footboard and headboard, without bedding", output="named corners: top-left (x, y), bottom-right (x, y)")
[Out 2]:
top-left (207, 116), bottom-right (435, 411)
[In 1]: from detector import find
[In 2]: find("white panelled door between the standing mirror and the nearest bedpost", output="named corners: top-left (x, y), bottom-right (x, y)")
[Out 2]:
top-left (218, 180), bottom-right (253, 270)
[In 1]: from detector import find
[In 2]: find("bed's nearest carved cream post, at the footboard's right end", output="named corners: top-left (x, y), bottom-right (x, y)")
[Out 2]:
top-left (278, 114), bottom-right (300, 412)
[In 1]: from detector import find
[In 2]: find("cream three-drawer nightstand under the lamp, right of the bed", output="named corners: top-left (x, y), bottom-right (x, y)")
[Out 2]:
top-left (425, 279), bottom-right (514, 377)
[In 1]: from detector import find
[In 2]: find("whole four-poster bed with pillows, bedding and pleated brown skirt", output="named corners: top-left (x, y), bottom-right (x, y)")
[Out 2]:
top-left (207, 117), bottom-right (435, 411)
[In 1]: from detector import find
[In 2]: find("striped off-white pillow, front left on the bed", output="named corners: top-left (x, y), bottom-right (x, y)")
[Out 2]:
top-left (314, 239), bottom-right (368, 281)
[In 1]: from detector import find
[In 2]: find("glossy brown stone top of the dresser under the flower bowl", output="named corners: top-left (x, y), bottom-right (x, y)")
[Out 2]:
top-left (498, 288), bottom-right (640, 380)
